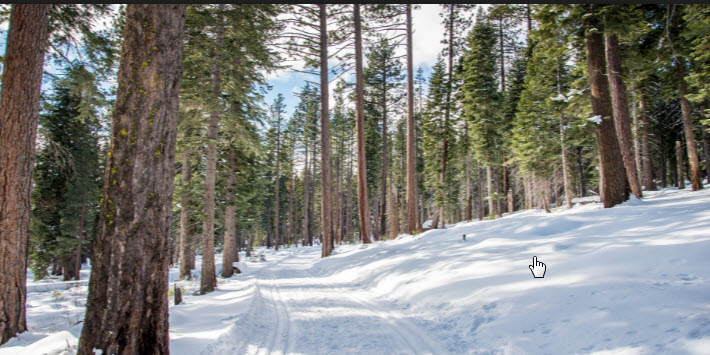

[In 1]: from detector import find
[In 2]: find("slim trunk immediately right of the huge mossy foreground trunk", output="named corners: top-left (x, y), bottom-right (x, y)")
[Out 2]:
top-left (180, 128), bottom-right (195, 280)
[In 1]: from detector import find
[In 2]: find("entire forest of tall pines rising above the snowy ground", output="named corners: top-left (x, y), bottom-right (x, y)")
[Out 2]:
top-left (0, 4), bottom-right (710, 354)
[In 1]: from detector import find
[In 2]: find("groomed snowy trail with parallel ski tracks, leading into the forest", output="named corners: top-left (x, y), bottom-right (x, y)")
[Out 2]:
top-left (238, 252), bottom-right (446, 354)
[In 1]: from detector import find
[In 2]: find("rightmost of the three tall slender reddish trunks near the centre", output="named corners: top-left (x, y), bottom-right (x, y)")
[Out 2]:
top-left (404, 4), bottom-right (417, 234)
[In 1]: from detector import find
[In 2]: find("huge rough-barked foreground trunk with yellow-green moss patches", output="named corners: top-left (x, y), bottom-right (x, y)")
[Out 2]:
top-left (79, 4), bottom-right (185, 354)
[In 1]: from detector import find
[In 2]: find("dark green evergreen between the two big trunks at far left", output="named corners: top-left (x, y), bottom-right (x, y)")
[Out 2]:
top-left (30, 66), bottom-right (103, 280)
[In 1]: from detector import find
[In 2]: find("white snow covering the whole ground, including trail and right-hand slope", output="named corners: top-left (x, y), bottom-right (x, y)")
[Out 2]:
top-left (0, 186), bottom-right (710, 355)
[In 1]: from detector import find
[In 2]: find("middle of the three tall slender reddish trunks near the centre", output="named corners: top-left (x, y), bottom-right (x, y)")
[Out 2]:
top-left (353, 4), bottom-right (371, 243)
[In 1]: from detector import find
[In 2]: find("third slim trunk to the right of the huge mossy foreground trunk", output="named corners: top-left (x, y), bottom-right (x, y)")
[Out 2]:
top-left (222, 147), bottom-right (237, 277)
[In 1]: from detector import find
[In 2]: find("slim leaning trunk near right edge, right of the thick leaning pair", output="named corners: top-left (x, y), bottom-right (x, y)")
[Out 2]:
top-left (675, 58), bottom-right (703, 191)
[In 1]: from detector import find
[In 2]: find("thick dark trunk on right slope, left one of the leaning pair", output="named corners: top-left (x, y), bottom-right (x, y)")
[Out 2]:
top-left (585, 30), bottom-right (629, 208)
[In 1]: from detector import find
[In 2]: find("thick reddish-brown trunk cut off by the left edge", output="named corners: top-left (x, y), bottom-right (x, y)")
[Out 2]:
top-left (0, 4), bottom-right (50, 344)
